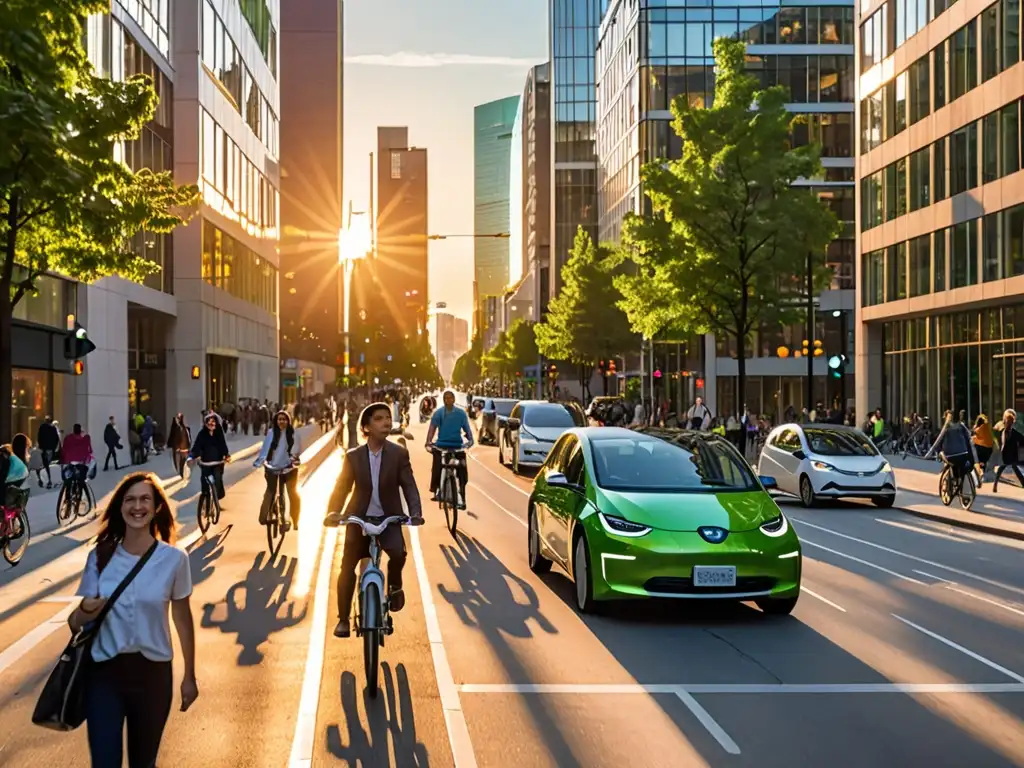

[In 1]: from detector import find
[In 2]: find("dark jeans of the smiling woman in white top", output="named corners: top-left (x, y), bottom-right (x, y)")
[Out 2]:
top-left (85, 653), bottom-right (173, 768)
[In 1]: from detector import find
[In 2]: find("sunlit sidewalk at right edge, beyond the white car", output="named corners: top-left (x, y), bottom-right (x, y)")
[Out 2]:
top-left (887, 456), bottom-right (1024, 541)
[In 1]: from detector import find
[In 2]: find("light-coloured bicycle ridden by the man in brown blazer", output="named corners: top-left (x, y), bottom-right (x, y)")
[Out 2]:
top-left (341, 515), bottom-right (423, 698)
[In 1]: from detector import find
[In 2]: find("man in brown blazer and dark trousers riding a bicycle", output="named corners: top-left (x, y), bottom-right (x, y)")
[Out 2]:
top-left (315, 402), bottom-right (423, 637)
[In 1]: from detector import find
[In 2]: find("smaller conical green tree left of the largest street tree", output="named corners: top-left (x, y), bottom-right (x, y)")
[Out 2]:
top-left (535, 226), bottom-right (637, 398)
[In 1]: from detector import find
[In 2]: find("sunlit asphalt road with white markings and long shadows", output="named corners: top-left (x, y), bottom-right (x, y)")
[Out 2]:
top-left (6, 426), bottom-right (1024, 768)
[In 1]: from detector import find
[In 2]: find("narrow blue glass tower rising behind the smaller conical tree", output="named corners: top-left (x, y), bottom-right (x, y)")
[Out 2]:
top-left (548, 0), bottom-right (598, 297)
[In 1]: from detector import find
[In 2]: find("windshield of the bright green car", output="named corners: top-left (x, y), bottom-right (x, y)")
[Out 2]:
top-left (591, 435), bottom-right (760, 494)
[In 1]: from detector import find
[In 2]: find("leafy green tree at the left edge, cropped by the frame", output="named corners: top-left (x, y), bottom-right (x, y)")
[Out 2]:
top-left (0, 0), bottom-right (198, 439)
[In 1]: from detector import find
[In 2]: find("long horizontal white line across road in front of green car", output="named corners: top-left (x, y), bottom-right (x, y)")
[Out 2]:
top-left (459, 683), bottom-right (1024, 695)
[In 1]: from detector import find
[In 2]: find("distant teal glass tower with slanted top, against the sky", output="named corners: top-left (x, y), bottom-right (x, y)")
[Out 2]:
top-left (473, 96), bottom-right (519, 300)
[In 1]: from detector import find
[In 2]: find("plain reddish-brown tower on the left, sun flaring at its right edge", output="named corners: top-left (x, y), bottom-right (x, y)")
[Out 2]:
top-left (281, 0), bottom-right (344, 402)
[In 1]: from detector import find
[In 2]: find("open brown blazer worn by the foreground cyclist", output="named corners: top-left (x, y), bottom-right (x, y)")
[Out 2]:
top-left (327, 441), bottom-right (423, 517)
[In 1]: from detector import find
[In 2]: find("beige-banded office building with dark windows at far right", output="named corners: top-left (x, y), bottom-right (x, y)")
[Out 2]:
top-left (855, 0), bottom-right (1024, 421)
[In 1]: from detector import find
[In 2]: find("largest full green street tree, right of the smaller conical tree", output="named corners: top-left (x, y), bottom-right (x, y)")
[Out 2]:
top-left (615, 38), bottom-right (840, 450)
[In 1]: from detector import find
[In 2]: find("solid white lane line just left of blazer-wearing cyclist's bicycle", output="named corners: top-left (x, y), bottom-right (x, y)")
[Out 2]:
top-left (288, 527), bottom-right (338, 768)
